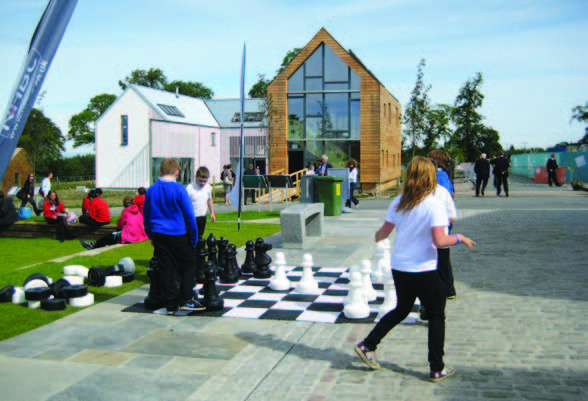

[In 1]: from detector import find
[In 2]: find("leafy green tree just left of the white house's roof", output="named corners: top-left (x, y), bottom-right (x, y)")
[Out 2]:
top-left (67, 93), bottom-right (116, 148)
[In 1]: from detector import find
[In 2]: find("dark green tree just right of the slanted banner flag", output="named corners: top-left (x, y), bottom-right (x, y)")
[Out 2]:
top-left (17, 108), bottom-right (64, 174)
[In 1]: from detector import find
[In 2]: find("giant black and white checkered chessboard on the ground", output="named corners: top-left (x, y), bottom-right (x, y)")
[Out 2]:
top-left (125, 266), bottom-right (419, 324)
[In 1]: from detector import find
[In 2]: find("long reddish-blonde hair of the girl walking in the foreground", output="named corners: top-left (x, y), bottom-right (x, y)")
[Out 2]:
top-left (396, 156), bottom-right (437, 212)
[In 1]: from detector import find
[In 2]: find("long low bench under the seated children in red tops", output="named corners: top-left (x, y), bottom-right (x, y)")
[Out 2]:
top-left (0, 221), bottom-right (118, 241)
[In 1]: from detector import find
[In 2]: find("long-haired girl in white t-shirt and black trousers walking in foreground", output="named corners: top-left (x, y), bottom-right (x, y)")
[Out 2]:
top-left (355, 156), bottom-right (476, 381)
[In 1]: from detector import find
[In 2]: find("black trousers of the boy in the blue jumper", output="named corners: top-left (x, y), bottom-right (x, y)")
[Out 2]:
top-left (151, 233), bottom-right (197, 311)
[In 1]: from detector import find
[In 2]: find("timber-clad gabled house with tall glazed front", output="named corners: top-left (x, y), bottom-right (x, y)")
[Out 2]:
top-left (268, 28), bottom-right (402, 192)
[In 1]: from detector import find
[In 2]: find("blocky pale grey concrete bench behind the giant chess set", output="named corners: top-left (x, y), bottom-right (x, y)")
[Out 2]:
top-left (280, 203), bottom-right (325, 249)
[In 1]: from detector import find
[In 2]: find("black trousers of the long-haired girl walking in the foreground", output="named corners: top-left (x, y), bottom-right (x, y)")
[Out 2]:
top-left (363, 270), bottom-right (445, 372)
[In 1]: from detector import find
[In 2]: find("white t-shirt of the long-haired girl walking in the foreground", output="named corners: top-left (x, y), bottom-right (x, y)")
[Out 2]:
top-left (386, 194), bottom-right (449, 273)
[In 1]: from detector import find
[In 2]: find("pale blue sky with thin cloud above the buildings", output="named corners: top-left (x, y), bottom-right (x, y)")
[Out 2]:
top-left (0, 0), bottom-right (588, 156)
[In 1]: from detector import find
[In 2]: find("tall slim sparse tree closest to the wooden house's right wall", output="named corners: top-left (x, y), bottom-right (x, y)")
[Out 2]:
top-left (403, 59), bottom-right (431, 157)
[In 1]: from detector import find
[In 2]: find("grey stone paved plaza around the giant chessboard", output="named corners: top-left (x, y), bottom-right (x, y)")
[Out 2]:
top-left (0, 177), bottom-right (588, 401)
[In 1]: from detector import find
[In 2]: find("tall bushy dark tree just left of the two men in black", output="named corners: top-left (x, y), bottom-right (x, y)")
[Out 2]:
top-left (451, 72), bottom-right (486, 161)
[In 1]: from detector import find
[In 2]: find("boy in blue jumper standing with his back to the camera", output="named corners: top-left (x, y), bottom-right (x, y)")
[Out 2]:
top-left (143, 159), bottom-right (205, 315)
